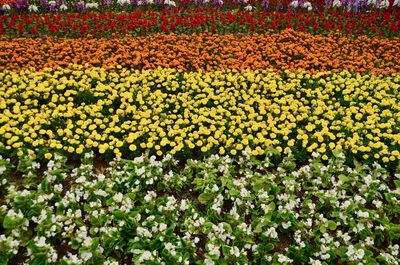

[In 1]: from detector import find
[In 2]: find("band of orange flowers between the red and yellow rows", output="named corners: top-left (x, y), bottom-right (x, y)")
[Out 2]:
top-left (0, 29), bottom-right (400, 74)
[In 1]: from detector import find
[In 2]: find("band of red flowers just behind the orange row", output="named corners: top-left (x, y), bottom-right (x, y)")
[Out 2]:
top-left (0, 8), bottom-right (400, 37)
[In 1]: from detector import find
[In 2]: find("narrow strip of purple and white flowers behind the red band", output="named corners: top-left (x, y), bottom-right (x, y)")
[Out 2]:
top-left (0, 0), bottom-right (400, 12)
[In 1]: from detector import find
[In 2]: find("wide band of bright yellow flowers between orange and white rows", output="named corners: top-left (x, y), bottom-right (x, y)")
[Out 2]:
top-left (0, 66), bottom-right (400, 162)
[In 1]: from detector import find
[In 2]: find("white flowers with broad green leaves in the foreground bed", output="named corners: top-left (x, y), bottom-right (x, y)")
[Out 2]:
top-left (0, 152), bottom-right (400, 264)
